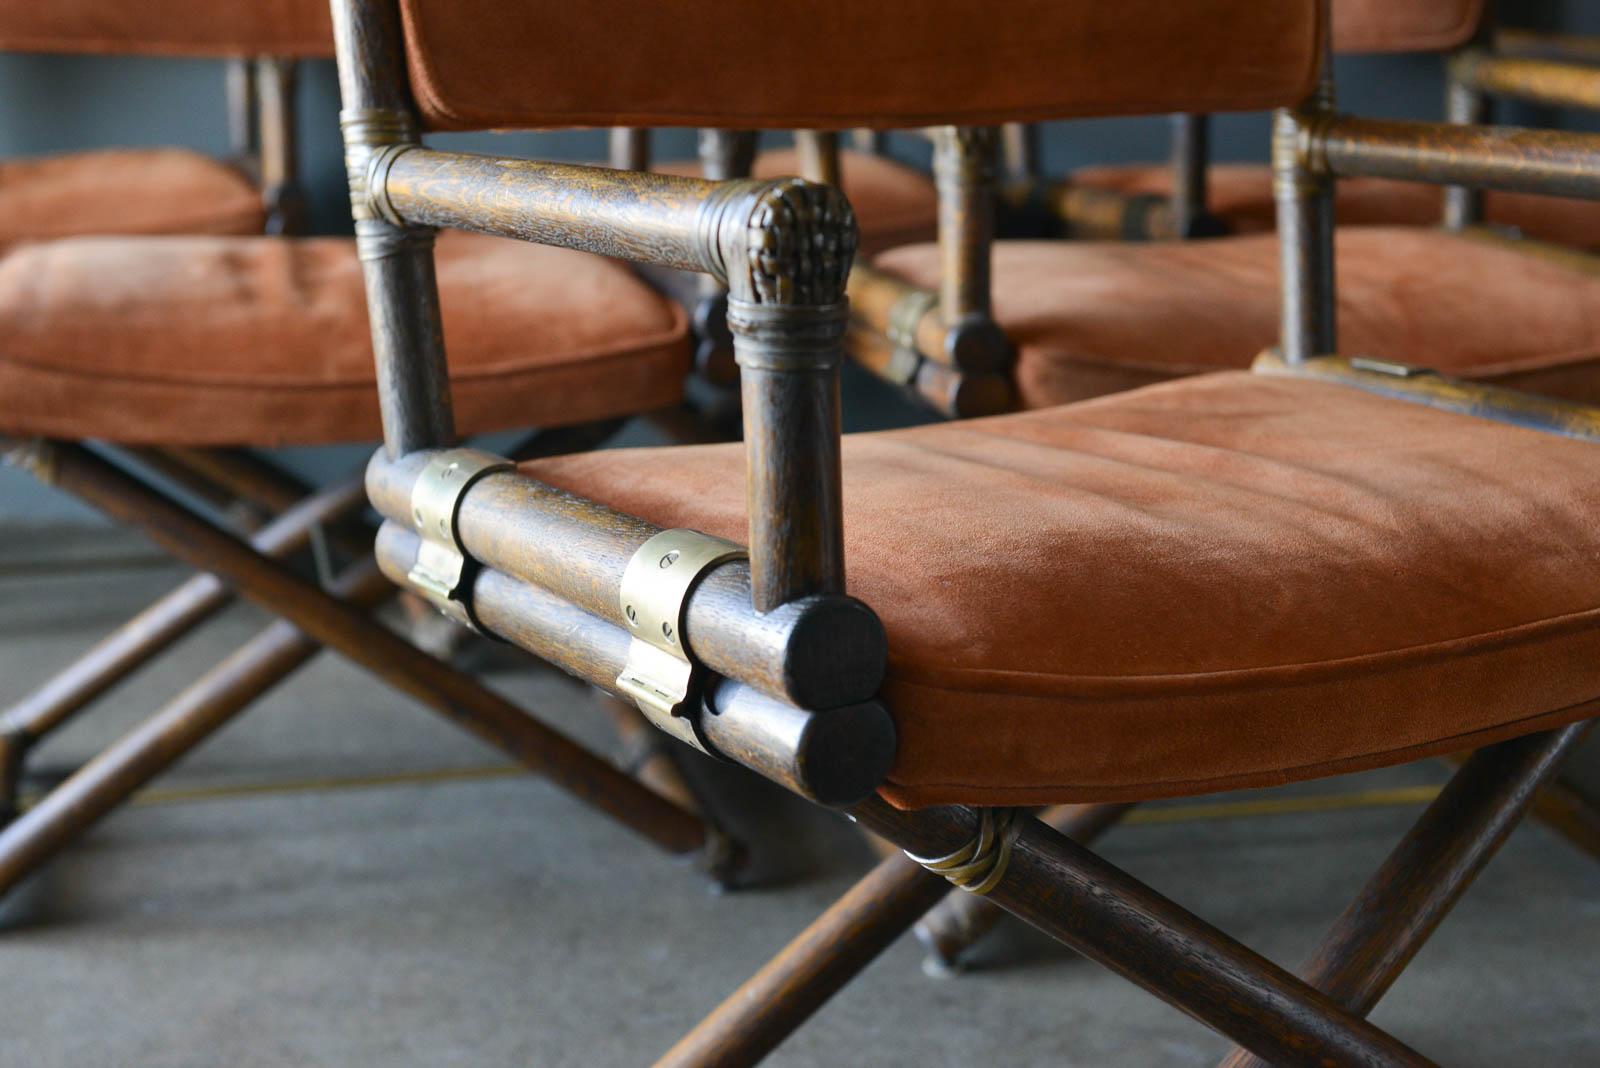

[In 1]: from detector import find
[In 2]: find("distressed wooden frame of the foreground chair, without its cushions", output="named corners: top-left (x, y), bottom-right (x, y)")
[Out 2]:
top-left (312, 0), bottom-right (1600, 1065)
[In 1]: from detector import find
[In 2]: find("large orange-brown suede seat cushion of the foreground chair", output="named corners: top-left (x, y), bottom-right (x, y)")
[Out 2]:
top-left (525, 373), bottom-right (1600, 806)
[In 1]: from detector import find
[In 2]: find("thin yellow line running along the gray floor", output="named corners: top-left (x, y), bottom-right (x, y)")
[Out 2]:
top-left (18, 764), bottom-right (1440, 823)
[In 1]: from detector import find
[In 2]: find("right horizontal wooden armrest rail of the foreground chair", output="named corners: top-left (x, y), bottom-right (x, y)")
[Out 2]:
top-left (1306, 115), bottom-right (1600, 200)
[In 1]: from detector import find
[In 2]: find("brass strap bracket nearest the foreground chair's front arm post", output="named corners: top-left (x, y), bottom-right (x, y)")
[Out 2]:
top-left (616, 529), bottom-right (749, 753)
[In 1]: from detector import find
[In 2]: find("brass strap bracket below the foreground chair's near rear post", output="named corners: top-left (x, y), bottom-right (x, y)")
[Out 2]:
top-left (406, 449), bottom-right (514, 630)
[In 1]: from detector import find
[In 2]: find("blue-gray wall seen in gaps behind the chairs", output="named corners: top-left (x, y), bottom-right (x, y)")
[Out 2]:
top-left (0, 0), bottom-right (1600, 523)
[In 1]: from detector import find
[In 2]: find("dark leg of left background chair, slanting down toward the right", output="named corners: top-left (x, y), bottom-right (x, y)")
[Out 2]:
top-left (48, 444), bottom-right (704, 852)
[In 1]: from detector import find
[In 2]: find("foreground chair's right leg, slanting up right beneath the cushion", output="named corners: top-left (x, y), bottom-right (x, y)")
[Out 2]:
top-left (1222, 723), bottom-right (1590, 1068)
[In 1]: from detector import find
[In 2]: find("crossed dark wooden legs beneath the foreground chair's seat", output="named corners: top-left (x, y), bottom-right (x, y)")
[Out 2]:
top-left (658, 721), bottom-right (1590, 1068)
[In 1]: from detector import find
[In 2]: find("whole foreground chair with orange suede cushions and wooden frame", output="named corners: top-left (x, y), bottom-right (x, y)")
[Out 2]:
top-left (334, 0), bottom-right (1600, 1065)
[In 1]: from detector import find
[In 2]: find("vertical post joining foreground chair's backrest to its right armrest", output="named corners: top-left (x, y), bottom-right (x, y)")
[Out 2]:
top-left (1272, 29), bottom-right (1338, 363)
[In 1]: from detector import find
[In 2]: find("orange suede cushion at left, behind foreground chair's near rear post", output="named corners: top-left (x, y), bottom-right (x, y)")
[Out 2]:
top-left (0, 233), bottom-right (690, 446)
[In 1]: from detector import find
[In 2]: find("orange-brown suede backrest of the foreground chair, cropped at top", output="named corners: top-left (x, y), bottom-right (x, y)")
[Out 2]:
top-left (402, 0), bottom-right (1322, 130)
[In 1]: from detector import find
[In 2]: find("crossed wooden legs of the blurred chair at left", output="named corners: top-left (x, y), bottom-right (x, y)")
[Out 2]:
top-left (0, 430), bottom-right (742, 894)
